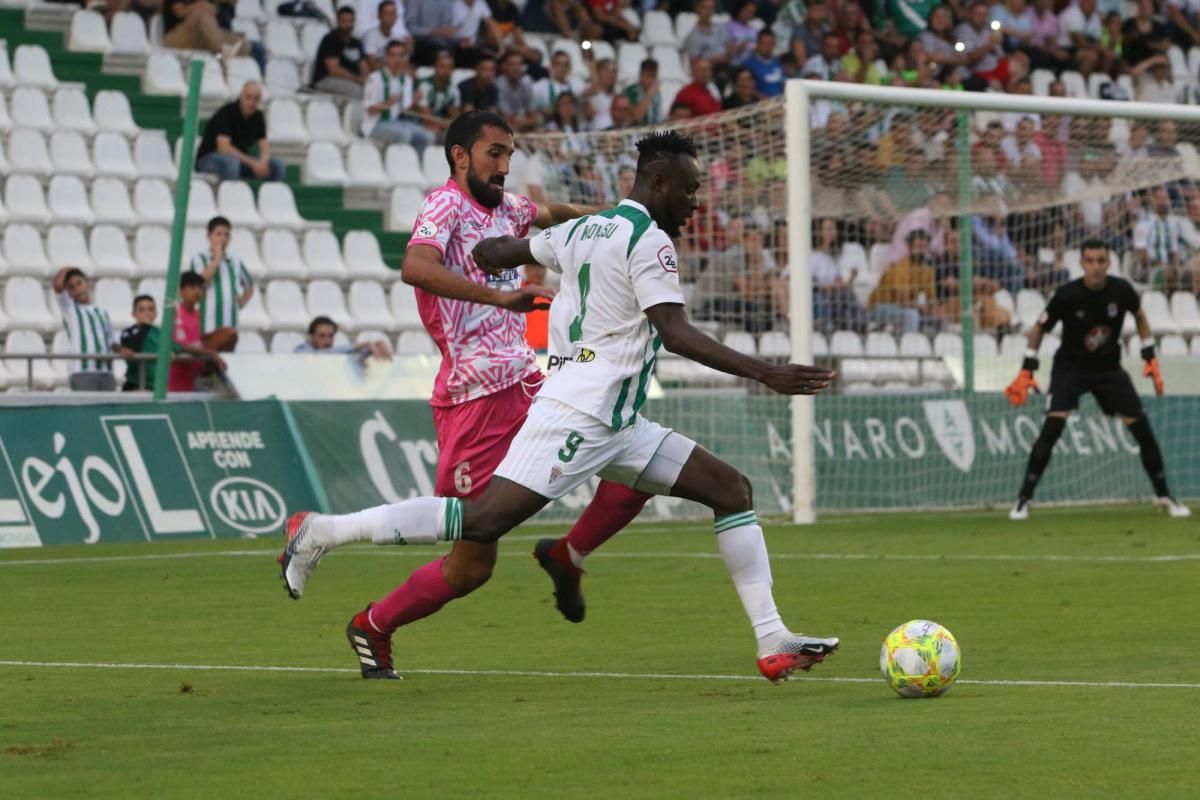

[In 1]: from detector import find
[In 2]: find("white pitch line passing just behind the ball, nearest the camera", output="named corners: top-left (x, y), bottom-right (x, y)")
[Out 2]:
top-left (0, 661), bottom-right (1200, 688)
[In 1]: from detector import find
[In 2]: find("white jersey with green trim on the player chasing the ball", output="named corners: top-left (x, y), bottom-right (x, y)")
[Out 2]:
top-left (529, 200), bottom-right (683, 431)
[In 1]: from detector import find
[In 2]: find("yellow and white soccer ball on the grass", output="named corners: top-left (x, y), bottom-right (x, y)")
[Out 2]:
top-left (880, 619), bottom-right (962, 697)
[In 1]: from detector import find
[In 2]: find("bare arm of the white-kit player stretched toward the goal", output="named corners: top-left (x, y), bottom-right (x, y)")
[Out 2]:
top-left (646, 302), bottom-right (834, 395)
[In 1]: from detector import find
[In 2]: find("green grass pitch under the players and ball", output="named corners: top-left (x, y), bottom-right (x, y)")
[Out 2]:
top-left (0, 506), bottom-right (1200, 800)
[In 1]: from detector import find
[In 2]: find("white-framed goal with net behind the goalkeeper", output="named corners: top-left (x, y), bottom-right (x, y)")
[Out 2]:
top-left (510, 82), bottom-right (1200, 522)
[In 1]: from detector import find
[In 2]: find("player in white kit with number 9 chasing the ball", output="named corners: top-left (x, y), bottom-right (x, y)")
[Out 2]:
top-left (288, 131), bottom-right (839, 681)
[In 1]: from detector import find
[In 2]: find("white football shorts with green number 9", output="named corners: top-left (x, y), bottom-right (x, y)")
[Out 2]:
top-left (494, 398), bottom-right (696, 500)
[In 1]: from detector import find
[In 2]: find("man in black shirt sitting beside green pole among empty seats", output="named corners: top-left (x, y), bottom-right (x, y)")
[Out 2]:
top-left (196, 80), bottom-right (284, 181)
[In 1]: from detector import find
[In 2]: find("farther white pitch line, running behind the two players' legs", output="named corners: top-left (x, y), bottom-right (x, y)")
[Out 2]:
top-left (0, 546), bottom-right (1200, 567)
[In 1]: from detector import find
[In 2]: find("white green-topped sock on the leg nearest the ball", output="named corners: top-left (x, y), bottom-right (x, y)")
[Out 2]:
top-left (713, 511), bottom-right (788, 650)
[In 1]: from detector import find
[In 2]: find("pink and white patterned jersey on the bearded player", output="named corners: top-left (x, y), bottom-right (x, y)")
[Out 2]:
top-left (408, 179), bottom-right (538, 407)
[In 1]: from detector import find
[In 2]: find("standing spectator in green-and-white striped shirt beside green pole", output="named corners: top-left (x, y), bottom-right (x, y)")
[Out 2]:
top-left (187, 217), bottom-right (254, 353)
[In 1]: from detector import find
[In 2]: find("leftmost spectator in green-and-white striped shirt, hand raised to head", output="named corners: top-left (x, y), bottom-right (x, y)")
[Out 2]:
top-left (54, 266), bottom-right (118, 392)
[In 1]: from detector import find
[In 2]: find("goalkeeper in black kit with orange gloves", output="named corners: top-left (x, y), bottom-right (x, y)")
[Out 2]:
top-left (1004, 239), bottom-right (1192, 521)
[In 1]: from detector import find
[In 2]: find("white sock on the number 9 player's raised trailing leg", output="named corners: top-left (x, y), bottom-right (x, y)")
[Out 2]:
top-left (325, 498), bottom-right (462, 547)
